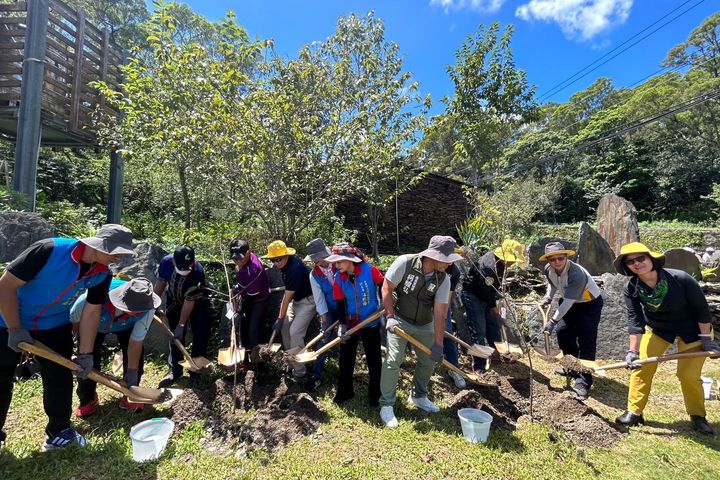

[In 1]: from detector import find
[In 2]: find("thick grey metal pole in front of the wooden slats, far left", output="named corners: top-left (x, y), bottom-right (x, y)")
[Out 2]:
top-left (13, 0), bottom-right (50, 212)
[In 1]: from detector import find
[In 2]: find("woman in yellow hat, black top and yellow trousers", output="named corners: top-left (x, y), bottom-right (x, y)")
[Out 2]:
top-left (615, 242), bottom-right (720, 435)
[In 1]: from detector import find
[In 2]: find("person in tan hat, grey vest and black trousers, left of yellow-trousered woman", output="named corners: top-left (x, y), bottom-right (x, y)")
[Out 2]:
top-left (540, 242), bottom-right (603, 400)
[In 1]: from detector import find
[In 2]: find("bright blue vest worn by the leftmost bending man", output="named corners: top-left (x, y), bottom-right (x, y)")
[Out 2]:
top-left (0, 238), bottom-right (108, 330)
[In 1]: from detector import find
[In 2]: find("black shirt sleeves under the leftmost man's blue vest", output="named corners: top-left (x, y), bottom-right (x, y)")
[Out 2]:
top-left (7, 238), bottom-right (112, 305)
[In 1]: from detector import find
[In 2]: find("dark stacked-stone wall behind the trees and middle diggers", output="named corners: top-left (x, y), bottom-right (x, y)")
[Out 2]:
top-left (335, 173), bottom-right (472, 253)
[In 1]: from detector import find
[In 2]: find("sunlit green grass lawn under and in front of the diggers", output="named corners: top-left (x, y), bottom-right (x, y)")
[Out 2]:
top-left (0, 352), bottom-right (720, 480)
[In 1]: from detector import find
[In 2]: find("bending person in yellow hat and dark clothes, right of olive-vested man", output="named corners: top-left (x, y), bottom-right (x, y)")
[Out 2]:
top-left (460, 239), bottom-right (525, 373)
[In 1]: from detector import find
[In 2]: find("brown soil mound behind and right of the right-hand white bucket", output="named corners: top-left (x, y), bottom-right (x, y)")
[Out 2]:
top-left (451, 372), bottom-right (624, 447)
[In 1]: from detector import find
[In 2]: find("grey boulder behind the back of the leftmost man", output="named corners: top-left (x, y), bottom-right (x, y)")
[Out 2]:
top-left (0, 212), bottom-right (57, 262)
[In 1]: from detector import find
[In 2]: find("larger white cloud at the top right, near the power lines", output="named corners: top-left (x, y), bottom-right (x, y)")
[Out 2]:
top-left (515, 0), bottom-right (633, 40)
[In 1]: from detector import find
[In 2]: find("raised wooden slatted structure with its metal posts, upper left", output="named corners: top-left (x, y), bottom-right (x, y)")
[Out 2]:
top-left (0, 0), bottom-right (123, 216)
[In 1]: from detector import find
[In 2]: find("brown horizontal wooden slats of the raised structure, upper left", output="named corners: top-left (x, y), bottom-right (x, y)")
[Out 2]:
top-left (0, 0), bottom-right (123, 139)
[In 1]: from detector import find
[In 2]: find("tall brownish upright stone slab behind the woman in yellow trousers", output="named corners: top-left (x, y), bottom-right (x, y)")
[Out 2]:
top-left (597, 193), bottom-right (640, 254)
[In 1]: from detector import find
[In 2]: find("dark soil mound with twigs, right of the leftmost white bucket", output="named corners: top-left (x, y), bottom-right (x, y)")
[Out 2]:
top-left (172, 370), bottom-right (327, 449)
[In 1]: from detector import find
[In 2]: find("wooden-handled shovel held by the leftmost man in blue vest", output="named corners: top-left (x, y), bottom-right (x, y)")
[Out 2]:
top-left (19, 341), bottom-right (183, 404)
